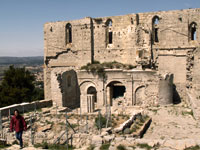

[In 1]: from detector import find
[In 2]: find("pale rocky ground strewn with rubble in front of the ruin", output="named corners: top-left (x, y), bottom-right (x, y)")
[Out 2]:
top-left (1, 104), bottom-right (200, 150)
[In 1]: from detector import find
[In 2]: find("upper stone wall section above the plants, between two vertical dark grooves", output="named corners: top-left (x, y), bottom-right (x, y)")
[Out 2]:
top-left (93, 14), bottom-right (150, 65)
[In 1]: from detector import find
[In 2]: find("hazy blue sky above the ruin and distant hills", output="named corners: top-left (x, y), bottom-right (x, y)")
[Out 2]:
top-left (0, 0), bottom-right (200, 56)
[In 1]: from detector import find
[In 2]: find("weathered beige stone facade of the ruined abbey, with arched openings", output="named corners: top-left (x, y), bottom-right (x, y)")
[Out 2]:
top-left (44, 8), bottom-right (200, 112)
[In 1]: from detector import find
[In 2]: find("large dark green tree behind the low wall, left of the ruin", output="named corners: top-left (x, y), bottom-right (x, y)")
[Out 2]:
top-left (0, 66), bottom-right (44, 107)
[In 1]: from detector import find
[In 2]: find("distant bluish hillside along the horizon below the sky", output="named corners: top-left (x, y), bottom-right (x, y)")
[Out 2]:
top-left (0, 56), bottom-right (44, 65)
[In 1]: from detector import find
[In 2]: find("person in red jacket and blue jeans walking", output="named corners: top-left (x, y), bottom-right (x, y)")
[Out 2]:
top-left (10, 109), bottom-right (27, 148)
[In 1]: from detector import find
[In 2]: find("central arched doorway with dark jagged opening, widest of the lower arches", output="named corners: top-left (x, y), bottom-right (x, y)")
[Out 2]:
top-left (106, 81), bottom-right (126, 106)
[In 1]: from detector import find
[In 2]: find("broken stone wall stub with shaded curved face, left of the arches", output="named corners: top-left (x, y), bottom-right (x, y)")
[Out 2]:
top-left (49, 67), bottom-right (80, 108)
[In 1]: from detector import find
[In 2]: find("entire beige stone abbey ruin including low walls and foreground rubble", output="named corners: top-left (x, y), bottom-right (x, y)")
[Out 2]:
top-left (0, 8), bottom-right (200, 150)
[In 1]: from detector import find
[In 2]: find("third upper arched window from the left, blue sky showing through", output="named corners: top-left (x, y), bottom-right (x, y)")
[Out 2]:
top-left (152, 16), bottom-right (160, 43)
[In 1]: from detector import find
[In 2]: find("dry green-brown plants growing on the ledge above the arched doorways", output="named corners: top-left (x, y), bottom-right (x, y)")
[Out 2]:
top-left (81, 61), bottom-right (135, 78)
